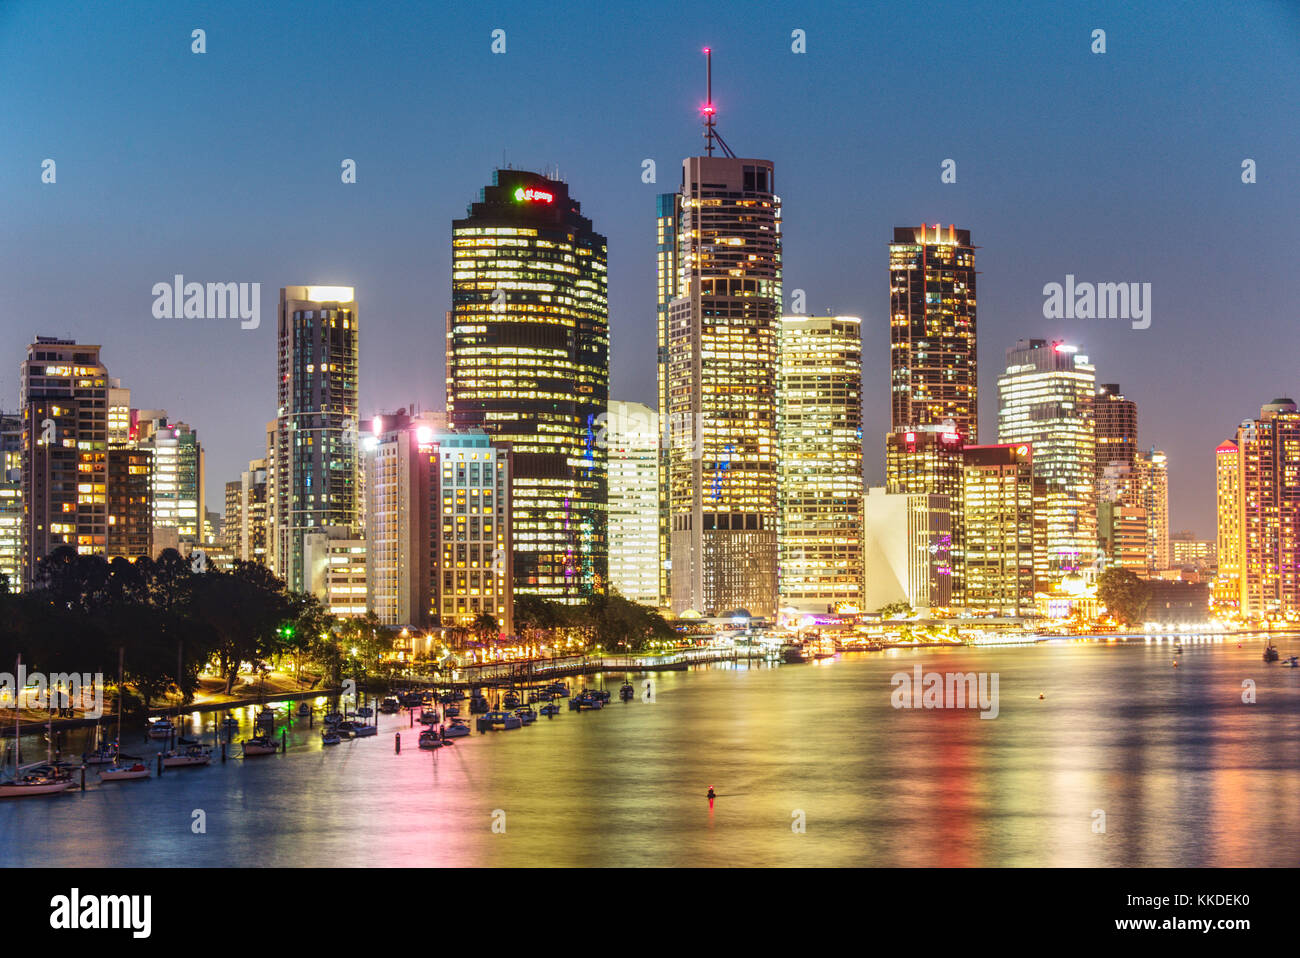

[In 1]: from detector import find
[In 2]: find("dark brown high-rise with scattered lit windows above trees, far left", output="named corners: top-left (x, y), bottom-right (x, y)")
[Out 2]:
top-left (18, 337), bottom-right (108, 589)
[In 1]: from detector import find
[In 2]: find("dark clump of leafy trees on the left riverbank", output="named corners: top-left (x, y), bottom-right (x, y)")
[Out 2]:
top-left (0, 547), bottom-right (345, 705)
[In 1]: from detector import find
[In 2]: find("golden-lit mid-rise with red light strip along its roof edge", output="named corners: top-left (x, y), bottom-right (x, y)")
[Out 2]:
top-left (962, 443), bottom-right (1045, 616)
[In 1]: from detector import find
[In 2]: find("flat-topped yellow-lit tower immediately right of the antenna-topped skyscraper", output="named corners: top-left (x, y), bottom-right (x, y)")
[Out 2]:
top-left (776, 316), bottom-right (863, 612)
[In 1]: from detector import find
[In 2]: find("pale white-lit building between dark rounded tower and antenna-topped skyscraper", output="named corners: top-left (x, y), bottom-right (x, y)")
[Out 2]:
top-left (605, 399), bottom-right (659, 606)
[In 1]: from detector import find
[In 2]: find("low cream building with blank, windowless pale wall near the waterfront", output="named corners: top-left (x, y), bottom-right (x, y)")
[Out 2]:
top-left (862, 487), bottom-right (953, 612)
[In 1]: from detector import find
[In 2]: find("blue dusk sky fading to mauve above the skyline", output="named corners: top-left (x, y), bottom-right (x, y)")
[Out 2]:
top-left (0, 0), bottom-right (1300, 537)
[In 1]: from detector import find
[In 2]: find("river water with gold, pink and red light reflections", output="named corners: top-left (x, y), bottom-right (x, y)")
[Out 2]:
top-left (0, 640), bottom-right (1300, 867)
